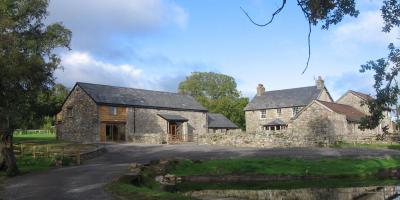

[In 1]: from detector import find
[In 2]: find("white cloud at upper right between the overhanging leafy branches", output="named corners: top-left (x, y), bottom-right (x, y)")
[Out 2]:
top-left (332, 11), bottom-right (400, 47)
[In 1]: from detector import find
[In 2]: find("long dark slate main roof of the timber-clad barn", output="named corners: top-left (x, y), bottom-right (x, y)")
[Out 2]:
top-left (77, 82), bottom-right (207, 111)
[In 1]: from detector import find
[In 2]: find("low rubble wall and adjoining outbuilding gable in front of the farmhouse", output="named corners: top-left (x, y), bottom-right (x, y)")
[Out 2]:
top-left (203, 101), bottom-right (388, 147)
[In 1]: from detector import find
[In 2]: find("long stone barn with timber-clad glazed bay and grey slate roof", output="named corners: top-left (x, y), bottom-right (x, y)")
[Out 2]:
top-left (56, 83), bottom-right (238, 144)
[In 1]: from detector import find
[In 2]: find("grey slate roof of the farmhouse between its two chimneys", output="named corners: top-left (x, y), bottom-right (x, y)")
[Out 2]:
top-left (244, 86), bottom-right (322, 111)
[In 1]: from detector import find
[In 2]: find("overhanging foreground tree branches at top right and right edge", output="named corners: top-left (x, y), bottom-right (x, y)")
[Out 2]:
top-left (242, 0), bottom-right (400, 129)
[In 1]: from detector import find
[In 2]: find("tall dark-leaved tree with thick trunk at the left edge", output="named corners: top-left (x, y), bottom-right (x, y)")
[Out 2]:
top-left (0, 0), bottom-right (72, 175)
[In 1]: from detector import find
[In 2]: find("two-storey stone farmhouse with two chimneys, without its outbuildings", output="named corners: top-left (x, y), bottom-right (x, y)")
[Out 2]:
top-left (244, 78), bottom-right (333, 132)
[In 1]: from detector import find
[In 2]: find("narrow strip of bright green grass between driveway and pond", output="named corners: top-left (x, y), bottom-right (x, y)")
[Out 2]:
top-left (169, 158), bottom-right (400, 177)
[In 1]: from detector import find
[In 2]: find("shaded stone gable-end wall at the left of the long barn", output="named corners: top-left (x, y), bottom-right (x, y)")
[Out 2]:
top-left (56, 86), bottom-right (99, 143)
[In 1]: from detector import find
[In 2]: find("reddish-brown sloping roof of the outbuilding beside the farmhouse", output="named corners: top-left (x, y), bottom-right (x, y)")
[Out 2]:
top-left (318, 101), bottom-right (365, 122)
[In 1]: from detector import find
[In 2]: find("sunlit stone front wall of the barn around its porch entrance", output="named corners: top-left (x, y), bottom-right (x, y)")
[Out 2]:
top-left (126, 108), bottom-right (207, 144)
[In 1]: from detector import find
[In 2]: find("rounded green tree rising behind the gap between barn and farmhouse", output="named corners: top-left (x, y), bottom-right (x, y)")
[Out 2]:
top-left (179, 72), bottom-right (249, 128)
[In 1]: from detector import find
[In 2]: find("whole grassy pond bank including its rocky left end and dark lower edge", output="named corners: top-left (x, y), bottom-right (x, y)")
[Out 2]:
top-left (107, 158), bottom-right (400, 199)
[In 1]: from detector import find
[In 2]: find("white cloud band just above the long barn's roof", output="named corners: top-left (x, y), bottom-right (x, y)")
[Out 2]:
top-left (55, 51), bottom-right (194, 92)
